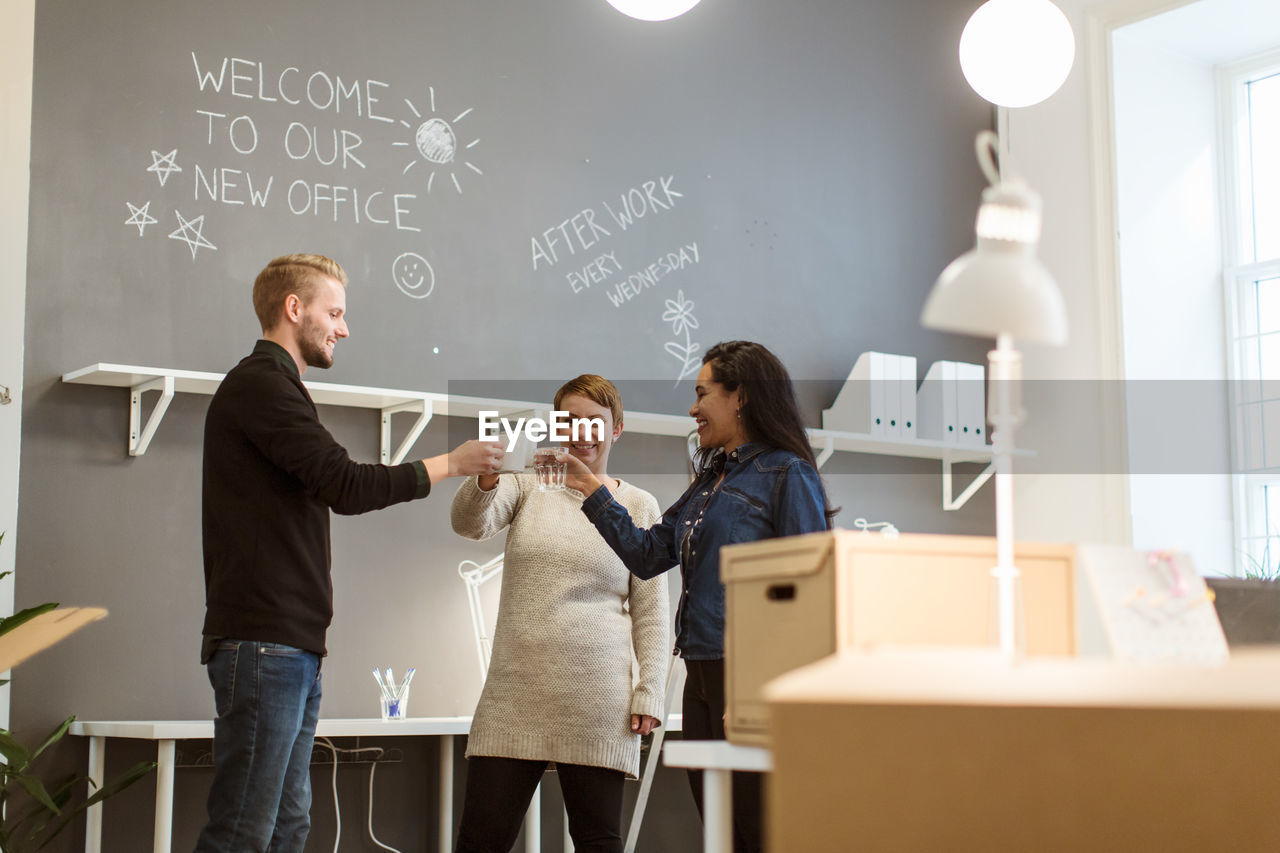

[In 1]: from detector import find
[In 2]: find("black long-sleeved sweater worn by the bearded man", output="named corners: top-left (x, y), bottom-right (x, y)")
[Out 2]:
top-left (202, 341), bottom-right (431, 654)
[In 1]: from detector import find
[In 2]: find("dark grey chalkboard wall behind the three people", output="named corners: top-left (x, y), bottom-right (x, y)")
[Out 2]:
top-left (22, 0), bottom-right (992, 850)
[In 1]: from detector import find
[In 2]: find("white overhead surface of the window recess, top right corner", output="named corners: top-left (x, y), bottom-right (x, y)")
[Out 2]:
top-left (1116, 0), bottom-right (1280, 65)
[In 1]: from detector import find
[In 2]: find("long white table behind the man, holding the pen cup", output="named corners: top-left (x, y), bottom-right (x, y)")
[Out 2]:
top-left (70, 717), bottom-right (471, 853)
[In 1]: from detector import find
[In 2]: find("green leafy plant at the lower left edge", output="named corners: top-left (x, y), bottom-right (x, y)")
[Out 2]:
top-left (0, 533), bottom-right (156, 853)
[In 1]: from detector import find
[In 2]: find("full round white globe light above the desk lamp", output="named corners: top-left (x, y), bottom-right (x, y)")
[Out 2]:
top-left (962, 0), bottom-right (1075, 106)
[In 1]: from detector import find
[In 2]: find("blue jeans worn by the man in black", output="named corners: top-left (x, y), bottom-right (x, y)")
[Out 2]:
top-left (196, 639), bottom-right (320, 853)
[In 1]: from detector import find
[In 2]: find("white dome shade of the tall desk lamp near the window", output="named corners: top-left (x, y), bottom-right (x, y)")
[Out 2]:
top-left (920, 240), bottom-right (1066, 346)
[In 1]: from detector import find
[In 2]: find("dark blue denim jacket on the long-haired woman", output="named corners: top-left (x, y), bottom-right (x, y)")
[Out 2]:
top-left (582, 443), bottom-right (827, 661)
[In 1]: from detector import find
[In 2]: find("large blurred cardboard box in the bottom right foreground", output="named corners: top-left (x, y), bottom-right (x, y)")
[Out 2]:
top-left (765, 649), bottom-right (1280, 853)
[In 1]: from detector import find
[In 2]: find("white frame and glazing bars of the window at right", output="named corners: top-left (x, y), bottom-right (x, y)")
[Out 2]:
top-left (1216, 50), bottom-right (1280, 576)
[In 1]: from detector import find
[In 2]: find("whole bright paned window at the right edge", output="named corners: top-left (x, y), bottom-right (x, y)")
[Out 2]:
top-left (1219, 53), bottom-right (1280, 576)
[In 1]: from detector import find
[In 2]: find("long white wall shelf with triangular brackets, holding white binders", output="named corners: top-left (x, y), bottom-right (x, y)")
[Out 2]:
top-left (63, 362), bottom-right (995, 510)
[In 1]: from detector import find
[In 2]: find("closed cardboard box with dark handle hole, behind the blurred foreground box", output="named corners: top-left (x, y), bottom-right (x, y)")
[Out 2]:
top-left (721, 530), bottom-right (1076, 745)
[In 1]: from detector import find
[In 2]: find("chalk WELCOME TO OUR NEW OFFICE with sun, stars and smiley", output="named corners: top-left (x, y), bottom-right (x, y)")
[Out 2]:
top-left (125, 51), bottom-right (484, 266)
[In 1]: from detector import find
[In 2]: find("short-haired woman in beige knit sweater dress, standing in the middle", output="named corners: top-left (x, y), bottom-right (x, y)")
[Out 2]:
top-left (452, 374), bottom-right (671, 853)
